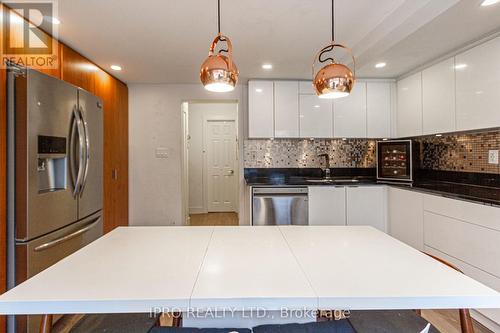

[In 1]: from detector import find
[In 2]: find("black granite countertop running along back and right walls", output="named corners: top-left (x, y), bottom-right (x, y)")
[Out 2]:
top-left (245, 168), bottom-right (500, 207)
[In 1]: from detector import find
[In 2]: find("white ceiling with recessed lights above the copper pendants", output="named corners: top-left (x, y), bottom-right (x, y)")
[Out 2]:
top-left (53, 0), bottom-right (500, 83)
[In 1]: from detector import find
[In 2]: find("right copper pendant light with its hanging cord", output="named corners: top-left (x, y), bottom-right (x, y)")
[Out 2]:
top-left (312, 0), bottom-right (356, 98)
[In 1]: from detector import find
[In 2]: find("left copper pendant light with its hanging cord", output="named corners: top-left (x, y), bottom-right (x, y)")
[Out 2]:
top-left (200, 0), bottom-right (238, 92)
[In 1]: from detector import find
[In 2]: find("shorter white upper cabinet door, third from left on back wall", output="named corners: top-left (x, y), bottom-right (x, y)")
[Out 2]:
top-left (299, 95), bottom-right (333, 138)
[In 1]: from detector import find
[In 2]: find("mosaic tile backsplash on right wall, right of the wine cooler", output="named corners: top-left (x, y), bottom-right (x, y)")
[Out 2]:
top-left (415, 130), bottom-right (500, 174)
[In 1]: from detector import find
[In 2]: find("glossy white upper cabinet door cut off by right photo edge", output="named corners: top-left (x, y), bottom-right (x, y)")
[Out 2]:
top-left (455, 37), bottom-right (500, 130)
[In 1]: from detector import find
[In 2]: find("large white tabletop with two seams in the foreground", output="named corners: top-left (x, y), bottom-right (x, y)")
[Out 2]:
top-left (0, 226), bottom-right (500, 314)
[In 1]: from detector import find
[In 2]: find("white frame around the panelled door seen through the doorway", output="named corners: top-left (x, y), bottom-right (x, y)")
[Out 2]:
top-left (202, 115), bottom-right (239, 213)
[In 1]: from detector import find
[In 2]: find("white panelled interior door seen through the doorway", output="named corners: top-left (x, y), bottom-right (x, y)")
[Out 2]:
top-left (206, 120), bottom-right (237, 212)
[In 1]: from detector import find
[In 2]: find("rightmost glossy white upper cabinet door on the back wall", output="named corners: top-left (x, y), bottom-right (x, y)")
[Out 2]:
top-left (366, 82), bottom-right (391, 138)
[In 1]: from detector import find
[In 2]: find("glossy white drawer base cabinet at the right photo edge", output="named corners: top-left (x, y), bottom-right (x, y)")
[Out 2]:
top-left (424, 195), bottom-right (500, 326)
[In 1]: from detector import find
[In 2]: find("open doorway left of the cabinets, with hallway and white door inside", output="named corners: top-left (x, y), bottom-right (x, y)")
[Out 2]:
top-left (182, 101), bottom-right (239, 225)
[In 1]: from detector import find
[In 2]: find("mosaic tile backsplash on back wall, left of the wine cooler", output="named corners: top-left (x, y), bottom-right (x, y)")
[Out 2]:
top-left (244, 139), bottom-right (376, 168)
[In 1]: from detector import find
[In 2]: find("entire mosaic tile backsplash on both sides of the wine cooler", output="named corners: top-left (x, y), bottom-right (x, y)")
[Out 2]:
top-left (244, 130), bottom-right (500, 174)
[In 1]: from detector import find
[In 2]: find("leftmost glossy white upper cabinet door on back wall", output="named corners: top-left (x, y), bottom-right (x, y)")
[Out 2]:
top-left (248, 81), bottom-right (274, 138)
